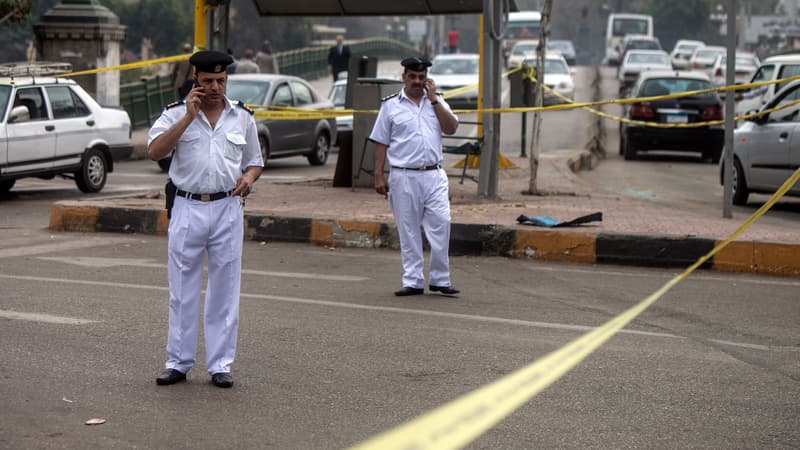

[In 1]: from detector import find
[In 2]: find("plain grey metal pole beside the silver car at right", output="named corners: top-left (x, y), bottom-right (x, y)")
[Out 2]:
top-left (722, 0), bottom-right (737, 219)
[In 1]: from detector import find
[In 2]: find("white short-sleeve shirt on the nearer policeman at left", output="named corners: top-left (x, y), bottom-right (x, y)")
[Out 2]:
top-left (147, 97), bottom-right (264, 194)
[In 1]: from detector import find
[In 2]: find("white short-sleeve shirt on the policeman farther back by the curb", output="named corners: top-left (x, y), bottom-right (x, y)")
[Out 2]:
top-left (369, 89), bottom-right (457, 167)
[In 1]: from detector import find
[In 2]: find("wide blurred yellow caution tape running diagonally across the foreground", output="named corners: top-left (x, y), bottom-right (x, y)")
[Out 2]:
top-left (353, 165), bottom-right (800, 450)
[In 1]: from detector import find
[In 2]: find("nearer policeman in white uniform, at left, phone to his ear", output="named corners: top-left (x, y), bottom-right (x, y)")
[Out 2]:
top-left (147, 51), bottom-right (264, 388)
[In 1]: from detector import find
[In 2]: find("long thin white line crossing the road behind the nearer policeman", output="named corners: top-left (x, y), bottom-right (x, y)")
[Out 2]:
top-left (0, 274), bottom-right (800, 352)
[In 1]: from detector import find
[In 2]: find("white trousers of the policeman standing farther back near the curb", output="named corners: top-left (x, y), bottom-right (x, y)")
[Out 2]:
top-left (389, 168), bottom-right (450, 288)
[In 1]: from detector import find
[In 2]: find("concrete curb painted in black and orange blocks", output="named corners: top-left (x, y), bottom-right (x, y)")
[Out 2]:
top-left (50, 201), bottom-right (800, 276)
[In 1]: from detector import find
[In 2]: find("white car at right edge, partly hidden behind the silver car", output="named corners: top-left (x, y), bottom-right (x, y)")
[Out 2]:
top-left (736, 53), bottom-right (800, 115)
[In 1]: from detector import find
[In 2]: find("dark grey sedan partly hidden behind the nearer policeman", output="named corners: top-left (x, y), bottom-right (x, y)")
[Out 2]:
top-left (159, 74), bottom-right (336, 170)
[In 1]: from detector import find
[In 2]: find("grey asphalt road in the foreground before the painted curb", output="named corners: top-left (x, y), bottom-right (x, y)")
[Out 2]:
top-left (0, 229), bottom-right (800, 449)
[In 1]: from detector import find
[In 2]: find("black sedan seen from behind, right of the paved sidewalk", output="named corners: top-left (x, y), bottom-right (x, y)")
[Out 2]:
top-left (619, 70), bottom-right (724, 163)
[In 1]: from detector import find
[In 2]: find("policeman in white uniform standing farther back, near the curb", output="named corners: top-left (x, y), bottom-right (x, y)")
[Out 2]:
top-left (369, 57), bottom-right (459, 296)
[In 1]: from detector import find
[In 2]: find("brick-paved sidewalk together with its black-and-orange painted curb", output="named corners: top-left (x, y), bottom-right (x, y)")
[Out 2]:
top-left (50, 124), bottom-right (800, 275)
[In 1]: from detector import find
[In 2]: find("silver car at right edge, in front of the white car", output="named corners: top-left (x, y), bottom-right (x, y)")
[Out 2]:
top-left (720, 80), bottom-right (800, 205)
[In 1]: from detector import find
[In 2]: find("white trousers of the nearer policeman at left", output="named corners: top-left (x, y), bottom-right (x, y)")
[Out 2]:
top-left (166, 197), bottom-right (244, 374)
